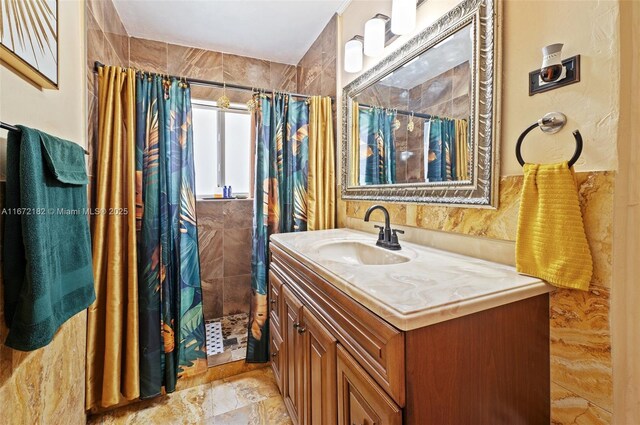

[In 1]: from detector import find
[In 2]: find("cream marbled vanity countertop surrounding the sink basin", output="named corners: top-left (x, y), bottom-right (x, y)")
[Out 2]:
top-left (271, 229), bottom-right (553, 331)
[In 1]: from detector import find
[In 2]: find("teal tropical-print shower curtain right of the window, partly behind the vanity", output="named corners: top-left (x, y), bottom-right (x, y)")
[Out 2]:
top-left (247, 93), bottom-right (309, 362)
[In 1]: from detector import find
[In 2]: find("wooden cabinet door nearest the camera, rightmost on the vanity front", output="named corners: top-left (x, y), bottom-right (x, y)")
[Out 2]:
top-left (337, 345), bottom-right (402, 425)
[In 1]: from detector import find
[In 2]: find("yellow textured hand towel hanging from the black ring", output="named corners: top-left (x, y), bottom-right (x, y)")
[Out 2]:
top-left (516, 161), bottom-right (593, 291)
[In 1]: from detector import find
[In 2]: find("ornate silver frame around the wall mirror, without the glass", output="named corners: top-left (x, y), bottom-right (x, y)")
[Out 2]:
top-left (341, 0), bottom-right (501, 208)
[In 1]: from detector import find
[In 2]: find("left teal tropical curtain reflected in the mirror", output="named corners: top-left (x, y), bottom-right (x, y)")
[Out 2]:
top-left (358, 108), bottom-right (396, 184)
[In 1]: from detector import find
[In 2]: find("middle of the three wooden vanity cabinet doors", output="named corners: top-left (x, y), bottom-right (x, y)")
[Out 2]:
top-left (298, 307), bottom-right (337, 425)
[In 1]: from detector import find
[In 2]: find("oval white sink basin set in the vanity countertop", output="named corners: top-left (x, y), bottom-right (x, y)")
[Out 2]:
top-left (318, 241), bottom-right (411, 266)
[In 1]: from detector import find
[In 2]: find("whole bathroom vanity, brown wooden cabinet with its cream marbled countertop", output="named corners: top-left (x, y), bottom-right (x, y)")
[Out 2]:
top-left (269, 229), bottom-right (551, 425)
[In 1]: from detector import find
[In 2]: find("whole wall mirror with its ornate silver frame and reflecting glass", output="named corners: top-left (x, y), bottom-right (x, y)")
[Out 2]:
top-left (342, 0), bottom-right (500, 208)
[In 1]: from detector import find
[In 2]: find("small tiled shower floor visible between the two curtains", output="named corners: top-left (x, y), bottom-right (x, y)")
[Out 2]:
top-left (206, 313), bottom-right (249, 367)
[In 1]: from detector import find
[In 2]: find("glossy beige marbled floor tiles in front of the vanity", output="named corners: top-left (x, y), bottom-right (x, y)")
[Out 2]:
top-left (89, 367), bottom-right (292, 425)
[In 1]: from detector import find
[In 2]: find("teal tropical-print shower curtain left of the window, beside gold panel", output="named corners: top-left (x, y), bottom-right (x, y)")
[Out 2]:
top-left (136, 74), bottom-right (207, 398)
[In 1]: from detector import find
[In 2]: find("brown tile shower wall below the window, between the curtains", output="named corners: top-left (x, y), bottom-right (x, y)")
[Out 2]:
top-left (196, 200), bottom-right (253, 320)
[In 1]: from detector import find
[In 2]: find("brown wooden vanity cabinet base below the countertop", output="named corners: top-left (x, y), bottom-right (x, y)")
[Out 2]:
top-left (269, 244), bottom-right (550, 425)
